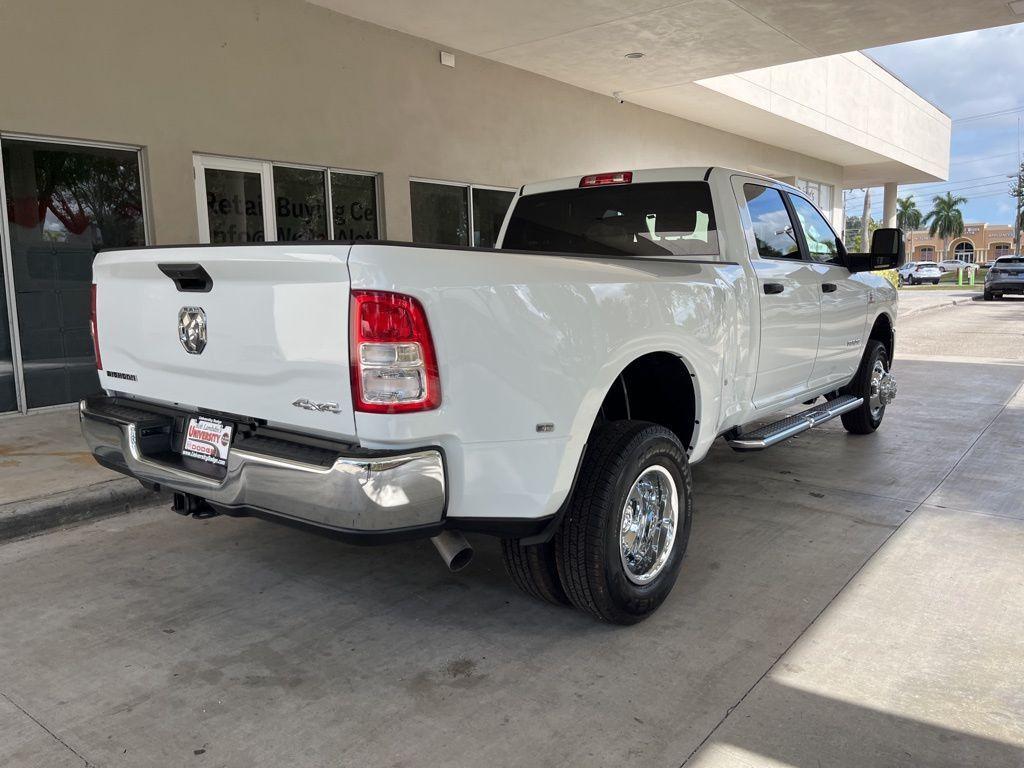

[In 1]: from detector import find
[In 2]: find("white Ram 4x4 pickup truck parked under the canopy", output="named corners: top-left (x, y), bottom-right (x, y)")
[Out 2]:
top-left (81, 168), bottom-right (902, 624)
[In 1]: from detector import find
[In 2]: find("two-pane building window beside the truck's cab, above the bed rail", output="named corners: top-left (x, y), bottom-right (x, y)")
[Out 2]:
top-left (409, 179), bottom-right (515, 248)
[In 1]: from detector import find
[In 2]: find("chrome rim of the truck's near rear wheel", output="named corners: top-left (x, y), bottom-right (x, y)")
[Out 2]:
top-left (618, 465), bottom-right (679, 584)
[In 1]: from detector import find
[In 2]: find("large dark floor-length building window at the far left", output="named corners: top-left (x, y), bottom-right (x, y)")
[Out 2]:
top-left (0, 137), bottom-right (146, 411)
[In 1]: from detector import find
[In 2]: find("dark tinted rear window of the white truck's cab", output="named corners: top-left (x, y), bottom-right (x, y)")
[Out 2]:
top-left (502, 181), bottom-right (718, 257)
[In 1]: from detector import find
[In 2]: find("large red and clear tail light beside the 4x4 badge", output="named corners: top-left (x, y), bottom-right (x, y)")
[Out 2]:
top-left (349, 291), bottom-right (441, 414)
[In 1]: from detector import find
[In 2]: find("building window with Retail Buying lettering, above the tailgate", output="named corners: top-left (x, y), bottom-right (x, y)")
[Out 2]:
top-left (194, 155), bottom-right (380, 244)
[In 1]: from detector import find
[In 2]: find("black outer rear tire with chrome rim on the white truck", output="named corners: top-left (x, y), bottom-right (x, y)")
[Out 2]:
top-left (555, 421), bottom-right (693, 625)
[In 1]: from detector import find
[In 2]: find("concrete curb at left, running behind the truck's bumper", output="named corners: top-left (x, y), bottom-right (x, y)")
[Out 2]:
top-left (0, 477), bottom-right (170, 542)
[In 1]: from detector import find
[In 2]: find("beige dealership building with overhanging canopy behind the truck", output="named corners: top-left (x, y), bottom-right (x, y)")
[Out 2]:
top-left (0, 0), bottom-right (1015, 412)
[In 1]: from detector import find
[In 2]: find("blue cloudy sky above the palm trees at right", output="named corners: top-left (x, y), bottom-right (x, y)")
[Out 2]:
top-left (846, 24), bottom-right (1024, 224)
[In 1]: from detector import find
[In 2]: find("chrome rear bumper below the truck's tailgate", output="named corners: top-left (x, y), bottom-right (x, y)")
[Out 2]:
top-left (79, 398), bottom-right (445, 532)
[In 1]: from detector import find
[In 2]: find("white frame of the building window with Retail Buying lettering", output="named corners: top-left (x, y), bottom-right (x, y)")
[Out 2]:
top-left (193, 153), bottom-right (384, 243)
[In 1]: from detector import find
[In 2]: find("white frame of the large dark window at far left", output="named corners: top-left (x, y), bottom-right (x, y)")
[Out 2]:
top-left (0, 131), bottom-right (153, 418)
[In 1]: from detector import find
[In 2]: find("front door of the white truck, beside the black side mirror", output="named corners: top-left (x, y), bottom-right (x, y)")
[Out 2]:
top-left (787, 193), bottom-right (869, 388)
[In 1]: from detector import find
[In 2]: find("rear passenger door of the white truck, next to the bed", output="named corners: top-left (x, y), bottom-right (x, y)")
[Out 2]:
top-left (733, 182), bottom-right (821, 408)
